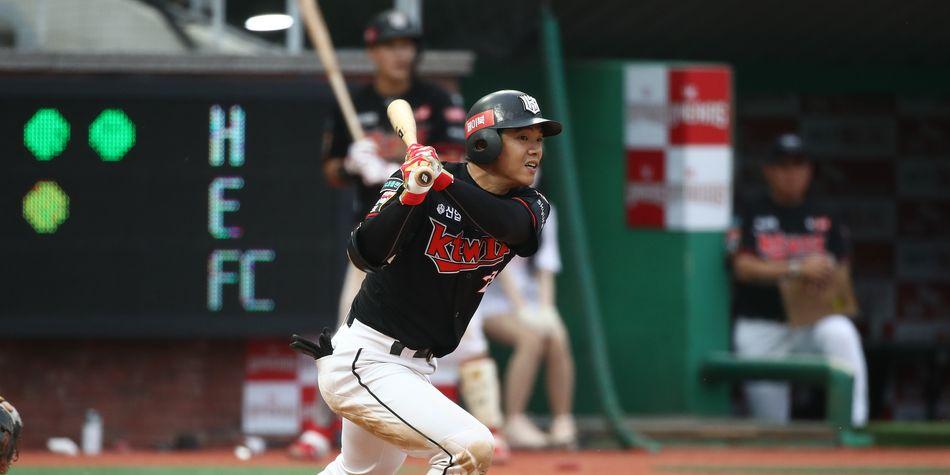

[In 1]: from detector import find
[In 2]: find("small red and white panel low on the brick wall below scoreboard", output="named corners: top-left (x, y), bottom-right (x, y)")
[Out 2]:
top-left (241, 339), bottom-right (300, 436)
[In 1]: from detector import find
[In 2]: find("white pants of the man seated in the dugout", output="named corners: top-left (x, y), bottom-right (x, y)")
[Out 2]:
top-left (733, 315), bottom-right (868, 427)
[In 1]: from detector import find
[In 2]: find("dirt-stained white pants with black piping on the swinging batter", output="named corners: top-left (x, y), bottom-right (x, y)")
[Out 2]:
top-left (317, 320), bottom-right (494, 475)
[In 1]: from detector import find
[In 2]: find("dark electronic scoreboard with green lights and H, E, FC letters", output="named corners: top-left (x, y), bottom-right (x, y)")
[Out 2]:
top-left (0, 75), bottom-right (351, 338)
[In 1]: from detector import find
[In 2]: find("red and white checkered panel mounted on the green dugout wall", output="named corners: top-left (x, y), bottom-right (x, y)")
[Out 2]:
top-left (624, 64), bottom-right (733, 231)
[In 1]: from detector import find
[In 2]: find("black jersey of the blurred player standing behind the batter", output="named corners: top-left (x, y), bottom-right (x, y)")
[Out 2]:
top-left (325, 80), bottom-right (465, 222)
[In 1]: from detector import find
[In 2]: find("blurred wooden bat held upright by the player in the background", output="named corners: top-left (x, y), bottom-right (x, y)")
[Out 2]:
top-left (297, 0), bottom-right (366, 141)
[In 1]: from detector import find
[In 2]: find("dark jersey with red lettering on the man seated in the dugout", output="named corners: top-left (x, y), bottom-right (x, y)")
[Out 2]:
top-left (728, 197), bottom-right (850, 322)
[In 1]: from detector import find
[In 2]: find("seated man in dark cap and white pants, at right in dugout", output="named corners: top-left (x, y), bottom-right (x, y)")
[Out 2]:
top-left (729, 133), bottom-right (868, 427)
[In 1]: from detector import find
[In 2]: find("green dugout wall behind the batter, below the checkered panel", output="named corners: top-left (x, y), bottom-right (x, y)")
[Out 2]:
top-left (462, 61), bottom-right (729, 415)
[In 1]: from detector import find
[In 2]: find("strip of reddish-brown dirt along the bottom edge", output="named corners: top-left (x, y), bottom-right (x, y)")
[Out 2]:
top-left (10, 448), bottom-right (950, 475)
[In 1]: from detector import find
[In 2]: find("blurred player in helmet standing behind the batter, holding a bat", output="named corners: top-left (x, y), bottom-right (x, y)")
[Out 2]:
top-left (323, 10), bottom-right (465, 323)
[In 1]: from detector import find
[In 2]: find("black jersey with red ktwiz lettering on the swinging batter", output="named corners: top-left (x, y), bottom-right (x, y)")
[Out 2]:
top-left (350, 163), bottom-right (550, 356)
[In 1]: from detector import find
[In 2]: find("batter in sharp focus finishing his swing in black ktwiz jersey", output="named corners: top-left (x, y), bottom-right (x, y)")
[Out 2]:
top-left (291, 90), bottom-right (561, 475)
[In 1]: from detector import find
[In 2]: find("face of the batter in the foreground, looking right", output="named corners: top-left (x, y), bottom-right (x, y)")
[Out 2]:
top-left (492, 125), bottom-right (544, 186)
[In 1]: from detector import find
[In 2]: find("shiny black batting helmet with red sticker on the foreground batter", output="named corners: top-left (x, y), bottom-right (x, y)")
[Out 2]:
top-left (465, 89), bottom-right (561, 165)
